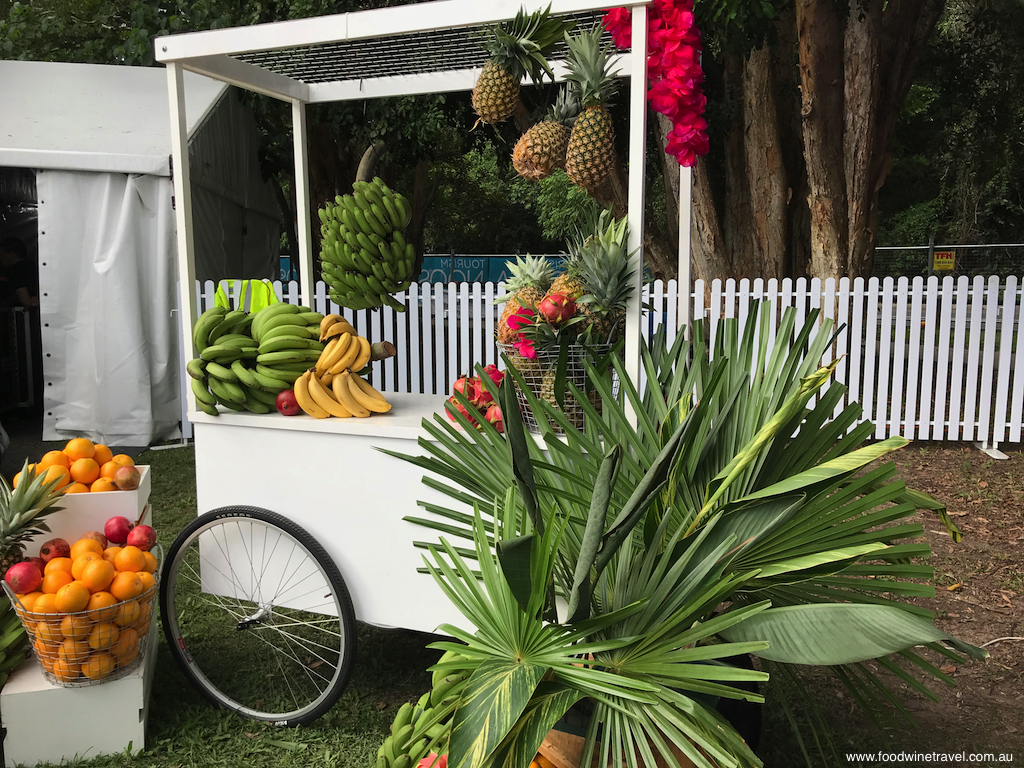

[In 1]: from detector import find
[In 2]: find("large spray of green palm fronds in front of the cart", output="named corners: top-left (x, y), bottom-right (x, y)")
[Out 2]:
top-left (385, 307), bottom-right (987, 768)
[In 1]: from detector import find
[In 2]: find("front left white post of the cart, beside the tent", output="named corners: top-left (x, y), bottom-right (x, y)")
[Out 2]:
top-left (167, 61), bottom-right (199, 433)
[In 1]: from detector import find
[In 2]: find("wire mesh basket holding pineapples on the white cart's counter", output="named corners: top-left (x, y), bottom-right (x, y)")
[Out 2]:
top-left (498, 344), bottom-right (618, 433)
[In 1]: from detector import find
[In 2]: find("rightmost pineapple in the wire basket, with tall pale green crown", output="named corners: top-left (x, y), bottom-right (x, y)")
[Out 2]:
top-left (578, 211), bottom-right (634, 342)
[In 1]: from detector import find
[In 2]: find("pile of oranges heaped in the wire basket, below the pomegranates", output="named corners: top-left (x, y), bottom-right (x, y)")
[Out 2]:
top-left (14, 539), bottom-right (157, 685)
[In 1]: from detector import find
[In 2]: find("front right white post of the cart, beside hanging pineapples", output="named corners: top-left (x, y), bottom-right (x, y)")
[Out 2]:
top-left (624, 0), bottom-right (647, 425)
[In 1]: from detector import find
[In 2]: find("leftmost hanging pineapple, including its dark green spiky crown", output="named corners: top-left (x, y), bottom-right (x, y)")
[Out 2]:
top-left (473, 5), bottom-right (575, 124)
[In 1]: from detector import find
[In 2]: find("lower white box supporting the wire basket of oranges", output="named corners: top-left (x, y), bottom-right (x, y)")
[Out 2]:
top-left (0, 611), bottom-right (160, 768)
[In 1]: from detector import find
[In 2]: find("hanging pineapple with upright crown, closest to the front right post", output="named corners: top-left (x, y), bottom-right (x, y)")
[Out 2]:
top-left (565, 26), bottom-right (617, 191)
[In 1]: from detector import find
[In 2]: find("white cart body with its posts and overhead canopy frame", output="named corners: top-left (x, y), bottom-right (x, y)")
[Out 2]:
top-left (156, 0), bottom-right (690, 631)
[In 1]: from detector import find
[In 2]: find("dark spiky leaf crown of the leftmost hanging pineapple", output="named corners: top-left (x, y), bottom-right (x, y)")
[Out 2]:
top-left (483, 4), bottom-right (575, 83)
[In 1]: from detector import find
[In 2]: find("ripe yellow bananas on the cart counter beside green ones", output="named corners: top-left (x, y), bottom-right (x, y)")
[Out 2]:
top-left (294, 314), bottom-right (394, 419)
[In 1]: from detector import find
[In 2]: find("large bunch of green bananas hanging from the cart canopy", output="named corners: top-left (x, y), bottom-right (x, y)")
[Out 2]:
top-left (317, 176), bottom-right (416, 312)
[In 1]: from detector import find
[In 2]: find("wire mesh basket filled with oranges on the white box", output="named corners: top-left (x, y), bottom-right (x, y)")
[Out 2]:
top-left (4, 553), bottom-right (160, 688)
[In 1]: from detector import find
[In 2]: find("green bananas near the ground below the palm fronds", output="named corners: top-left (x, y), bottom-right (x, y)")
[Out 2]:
top-left (377, 651), bottom-right (470, 768)
